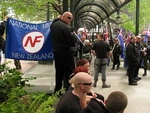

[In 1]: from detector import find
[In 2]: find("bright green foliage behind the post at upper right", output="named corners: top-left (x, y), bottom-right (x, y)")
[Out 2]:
top-left (122, 0), bottom-right (150, 33)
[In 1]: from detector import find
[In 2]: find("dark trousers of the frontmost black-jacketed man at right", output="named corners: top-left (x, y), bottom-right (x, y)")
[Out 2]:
top-left (127, 65), bottom-right (138, 83)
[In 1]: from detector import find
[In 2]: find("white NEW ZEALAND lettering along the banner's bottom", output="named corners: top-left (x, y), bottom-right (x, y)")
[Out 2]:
top-left (12, 52), bottom-right (53, 60)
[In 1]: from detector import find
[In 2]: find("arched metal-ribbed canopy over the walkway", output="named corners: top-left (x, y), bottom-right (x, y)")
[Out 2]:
top-left (74, 0), bottom-right (131, 30)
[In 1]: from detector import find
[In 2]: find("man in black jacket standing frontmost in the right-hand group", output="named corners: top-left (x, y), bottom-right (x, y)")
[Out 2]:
top-left (126, 36), bottom-right (140, 85)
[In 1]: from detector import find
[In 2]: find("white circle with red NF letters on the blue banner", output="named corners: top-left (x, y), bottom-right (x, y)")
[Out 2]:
top-left (22, 32), bottom-right (44, 53)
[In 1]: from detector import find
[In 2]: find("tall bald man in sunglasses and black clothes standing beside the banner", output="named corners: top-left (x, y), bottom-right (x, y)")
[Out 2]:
top-left (50, 12), bottom-right (77, 93)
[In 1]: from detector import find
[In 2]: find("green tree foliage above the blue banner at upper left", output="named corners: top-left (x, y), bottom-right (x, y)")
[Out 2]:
top-left (0, 0), bottom-right (62, 21)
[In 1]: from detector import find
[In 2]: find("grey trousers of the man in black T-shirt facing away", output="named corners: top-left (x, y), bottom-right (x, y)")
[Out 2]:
top-left (94, 58), bottom-right (107, 82)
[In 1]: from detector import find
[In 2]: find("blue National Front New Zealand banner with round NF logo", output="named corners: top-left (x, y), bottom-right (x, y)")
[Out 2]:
top-left (5, 18), bottom-right (53, 60)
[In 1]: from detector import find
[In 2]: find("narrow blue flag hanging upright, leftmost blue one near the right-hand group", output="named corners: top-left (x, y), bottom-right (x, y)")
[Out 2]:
top-left (117, 29), bottom-right (125, 58)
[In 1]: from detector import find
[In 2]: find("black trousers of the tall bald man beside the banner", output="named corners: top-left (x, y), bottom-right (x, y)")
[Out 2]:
top-left (54, 52), bottom-right (75, 93)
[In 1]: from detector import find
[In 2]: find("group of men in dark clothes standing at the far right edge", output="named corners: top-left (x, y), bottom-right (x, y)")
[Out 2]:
top-left (125, 35), bottom-right (150, 85)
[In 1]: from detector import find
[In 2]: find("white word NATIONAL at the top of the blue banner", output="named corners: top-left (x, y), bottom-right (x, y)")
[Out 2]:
top-left (9, 20), bottom-right (38, 30)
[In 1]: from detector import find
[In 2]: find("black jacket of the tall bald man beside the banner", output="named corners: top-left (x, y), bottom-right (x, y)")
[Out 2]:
top-left (50, 19), bottom-right (77, 52)
